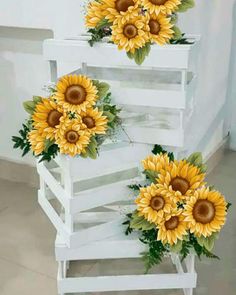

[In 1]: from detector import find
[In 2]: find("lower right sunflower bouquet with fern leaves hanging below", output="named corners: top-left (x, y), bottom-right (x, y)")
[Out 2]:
top-left (124, 145), bottom-right (231, 272)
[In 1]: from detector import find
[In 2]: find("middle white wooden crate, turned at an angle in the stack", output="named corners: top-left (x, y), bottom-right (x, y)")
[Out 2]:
top-left (37, 144), bottom-right (150, 248)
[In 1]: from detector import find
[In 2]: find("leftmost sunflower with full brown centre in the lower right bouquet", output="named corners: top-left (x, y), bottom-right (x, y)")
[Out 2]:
top-left (135, 183), bottom-right (176, 224)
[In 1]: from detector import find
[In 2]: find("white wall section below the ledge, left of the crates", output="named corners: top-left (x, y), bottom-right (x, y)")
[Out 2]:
top-left (0, 27), bottom-right (53, 163)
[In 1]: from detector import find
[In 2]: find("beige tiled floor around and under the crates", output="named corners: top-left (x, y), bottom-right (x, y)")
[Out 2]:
top-left (0, 152), bottom-right (236, 295)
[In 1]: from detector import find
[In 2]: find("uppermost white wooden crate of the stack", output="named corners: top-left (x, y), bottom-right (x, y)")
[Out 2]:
top-left (44, 36), bottom-right (200, 148)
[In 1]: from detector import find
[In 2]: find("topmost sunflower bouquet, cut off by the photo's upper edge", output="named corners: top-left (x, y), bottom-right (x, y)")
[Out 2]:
top-left (85, 0), bottom-right (195, 65)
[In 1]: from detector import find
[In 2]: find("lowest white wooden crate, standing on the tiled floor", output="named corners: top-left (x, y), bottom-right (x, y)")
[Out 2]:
top-left (55, 234), bottom-right (197, 295)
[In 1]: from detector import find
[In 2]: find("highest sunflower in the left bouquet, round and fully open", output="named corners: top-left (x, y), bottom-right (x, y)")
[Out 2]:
top-left (54, 75), bottom-right (98, 113)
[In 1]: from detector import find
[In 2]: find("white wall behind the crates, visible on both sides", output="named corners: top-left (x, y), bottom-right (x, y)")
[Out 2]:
top-left (0, 0), bottom-right (235, 162)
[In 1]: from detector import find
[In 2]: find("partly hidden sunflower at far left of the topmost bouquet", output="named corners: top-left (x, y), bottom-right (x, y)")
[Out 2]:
top-left (85, 1), bottom-right (104, 28)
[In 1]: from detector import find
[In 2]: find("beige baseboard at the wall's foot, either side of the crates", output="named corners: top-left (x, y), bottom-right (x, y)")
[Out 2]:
top-left (0, 137), bottom-right (228, 188)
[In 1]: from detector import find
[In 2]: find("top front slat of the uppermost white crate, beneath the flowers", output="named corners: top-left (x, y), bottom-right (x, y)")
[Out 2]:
top-left (43, 38), bottom-right (198, 69)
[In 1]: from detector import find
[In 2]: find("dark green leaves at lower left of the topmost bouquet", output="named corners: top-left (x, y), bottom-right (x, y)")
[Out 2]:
top-left (88, 19), bottom-right (111, 46)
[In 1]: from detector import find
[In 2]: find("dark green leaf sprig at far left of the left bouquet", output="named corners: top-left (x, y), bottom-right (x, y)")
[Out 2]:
top-left (12, 122), bottom-right (31, 157)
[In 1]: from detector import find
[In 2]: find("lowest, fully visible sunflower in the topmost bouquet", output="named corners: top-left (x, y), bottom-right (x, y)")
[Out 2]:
top-left (111, 13), bottom-right (149, 53)
